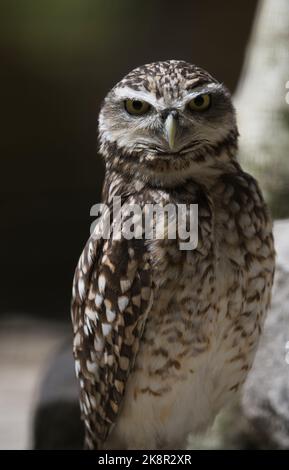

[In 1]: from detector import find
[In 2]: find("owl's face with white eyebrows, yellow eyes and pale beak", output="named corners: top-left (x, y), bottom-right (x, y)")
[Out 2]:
top-left (100, 83), bottom-right (234, 156)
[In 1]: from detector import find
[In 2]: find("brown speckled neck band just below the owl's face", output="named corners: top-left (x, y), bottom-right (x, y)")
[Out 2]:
top-left (101, 131), bottom-right (240, 188)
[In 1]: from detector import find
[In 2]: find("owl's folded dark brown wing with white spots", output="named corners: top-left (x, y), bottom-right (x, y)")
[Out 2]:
top-left (72, 229), bottom-right (152, 448)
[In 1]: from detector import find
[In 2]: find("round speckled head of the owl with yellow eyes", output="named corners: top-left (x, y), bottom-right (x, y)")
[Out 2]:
top-left (99, 60), bottom-right (238, 184)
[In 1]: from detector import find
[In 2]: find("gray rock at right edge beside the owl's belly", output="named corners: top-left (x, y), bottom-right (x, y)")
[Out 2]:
top-left (237, 220), bottom-right (289, 449)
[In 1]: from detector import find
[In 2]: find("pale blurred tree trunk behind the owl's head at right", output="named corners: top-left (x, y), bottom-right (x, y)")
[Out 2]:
top-left (235, 0), bottom-right (289, 217)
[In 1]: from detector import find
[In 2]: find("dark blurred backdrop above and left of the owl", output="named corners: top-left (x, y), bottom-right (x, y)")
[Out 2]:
top-left (0, 0), bottom-right (256, 319)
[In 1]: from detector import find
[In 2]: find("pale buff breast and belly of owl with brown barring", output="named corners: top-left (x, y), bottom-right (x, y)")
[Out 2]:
top-left (104, 173), bottom-right (274, 448)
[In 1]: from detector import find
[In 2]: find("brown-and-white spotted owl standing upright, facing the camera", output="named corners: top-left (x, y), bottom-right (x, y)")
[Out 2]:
top-left (72, 60), bottom-right (274, 449)
